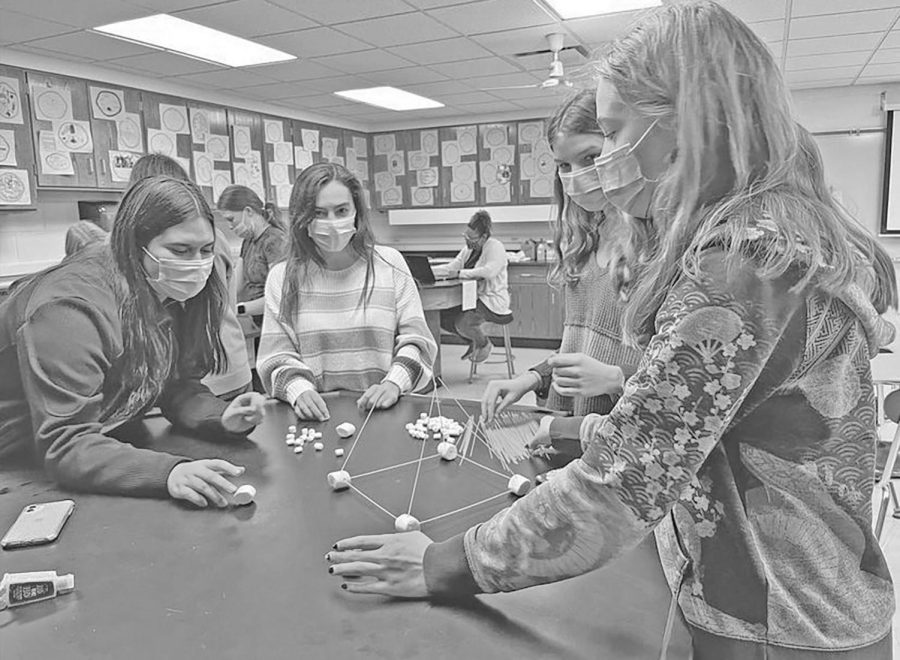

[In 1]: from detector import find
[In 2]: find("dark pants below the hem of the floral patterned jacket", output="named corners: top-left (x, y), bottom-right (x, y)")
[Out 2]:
top-left (688, 625), bottom-right (893, 660)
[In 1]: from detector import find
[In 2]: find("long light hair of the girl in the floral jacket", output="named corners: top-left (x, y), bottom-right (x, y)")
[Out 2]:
top-left (597, 0), bottom-right (897, 341)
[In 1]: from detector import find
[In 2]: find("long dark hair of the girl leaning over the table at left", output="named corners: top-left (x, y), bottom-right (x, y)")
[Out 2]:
top-left (106, 176), bottom-right (226, 418)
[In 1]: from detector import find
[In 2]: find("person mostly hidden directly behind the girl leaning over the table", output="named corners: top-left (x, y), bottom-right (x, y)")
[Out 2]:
top-left (128, 154), bottom-right (251, 401)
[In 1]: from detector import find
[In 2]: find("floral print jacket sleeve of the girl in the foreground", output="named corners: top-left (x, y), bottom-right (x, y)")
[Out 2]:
top-left (464, 253), bottom-right (802, 592)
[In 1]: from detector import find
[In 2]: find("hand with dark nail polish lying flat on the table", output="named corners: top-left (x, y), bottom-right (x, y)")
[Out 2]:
top-left (325, 532), bottom-right (432, 598)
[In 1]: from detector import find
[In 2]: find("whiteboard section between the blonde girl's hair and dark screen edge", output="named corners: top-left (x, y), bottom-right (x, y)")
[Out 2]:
top-left (814, 133), bottom-right (884, 234)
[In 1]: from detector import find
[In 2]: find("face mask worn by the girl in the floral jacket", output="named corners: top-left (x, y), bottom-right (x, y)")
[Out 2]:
top-left (594, 119), bottom-right (659, 218)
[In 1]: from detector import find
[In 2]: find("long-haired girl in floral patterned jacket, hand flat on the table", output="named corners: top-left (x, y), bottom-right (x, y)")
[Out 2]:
top-left (329, 0), bottom-right (897, 660)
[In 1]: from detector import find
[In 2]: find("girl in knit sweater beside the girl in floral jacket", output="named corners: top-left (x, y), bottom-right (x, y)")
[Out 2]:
top-left (481, 89), bottom-right (641, 455)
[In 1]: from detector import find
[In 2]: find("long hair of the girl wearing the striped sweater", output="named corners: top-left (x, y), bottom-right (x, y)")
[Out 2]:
top-left (279, 163), bottom-right (375, 323)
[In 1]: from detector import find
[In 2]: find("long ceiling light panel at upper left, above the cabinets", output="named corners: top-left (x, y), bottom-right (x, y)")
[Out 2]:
top-left (94, 14), bottom-right (297, 67)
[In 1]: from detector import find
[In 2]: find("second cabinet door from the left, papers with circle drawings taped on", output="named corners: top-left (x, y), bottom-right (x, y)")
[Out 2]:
top-left (27, 71), bottom-right (97, 188)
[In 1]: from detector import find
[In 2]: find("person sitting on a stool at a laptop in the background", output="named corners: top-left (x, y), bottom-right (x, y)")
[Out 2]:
top-left (433, 210), bottom-right (512, 362)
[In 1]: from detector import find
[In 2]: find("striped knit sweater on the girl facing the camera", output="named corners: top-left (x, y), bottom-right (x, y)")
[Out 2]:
top-left (256, 246), bottom-right (437, 405)
